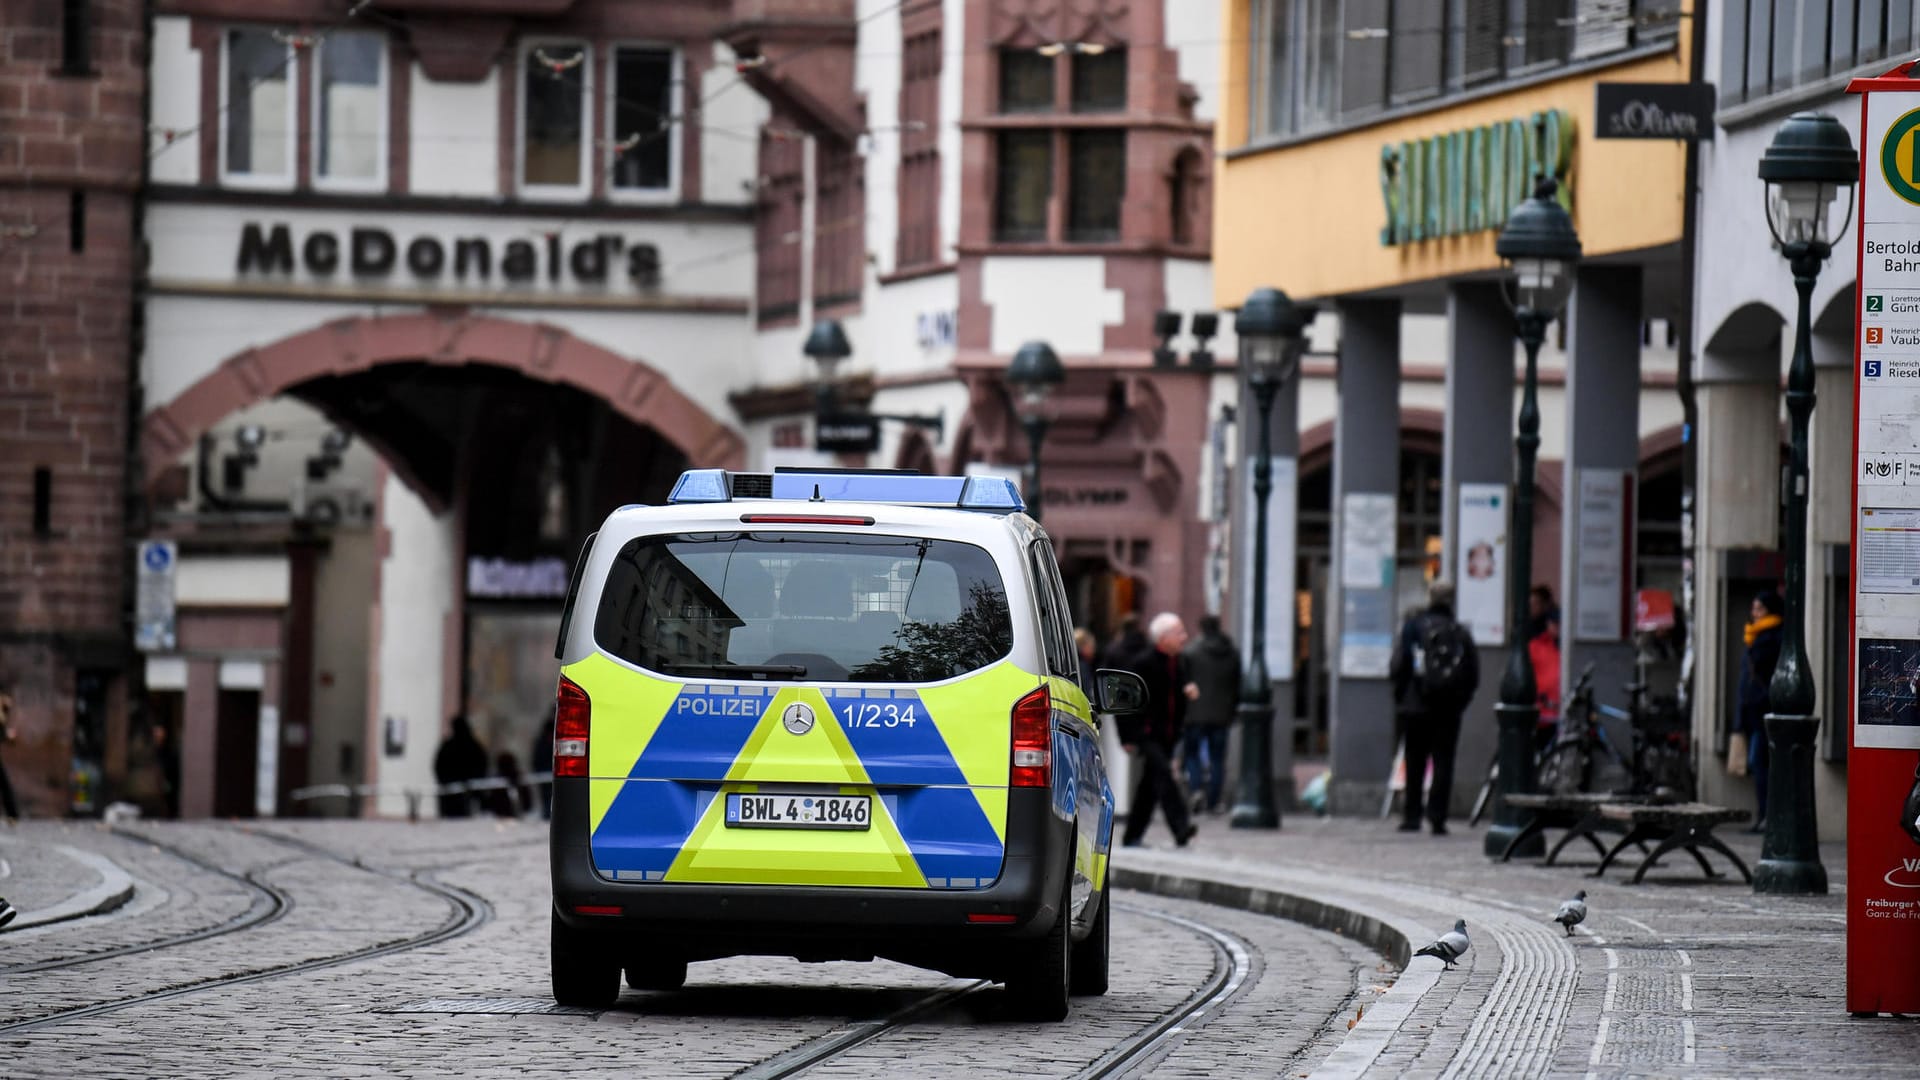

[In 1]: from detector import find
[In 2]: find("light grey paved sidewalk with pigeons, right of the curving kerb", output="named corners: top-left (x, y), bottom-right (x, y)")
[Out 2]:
top-left (1116, 817), bottom-right (1920, 1076)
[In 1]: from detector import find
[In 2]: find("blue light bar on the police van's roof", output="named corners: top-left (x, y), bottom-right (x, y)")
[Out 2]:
top-left (666, 469), bottom-right (1027, 513)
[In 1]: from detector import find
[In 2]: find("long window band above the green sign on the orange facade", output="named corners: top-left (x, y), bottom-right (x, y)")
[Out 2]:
top-left (1248, 0), bottom-right (1674, 138)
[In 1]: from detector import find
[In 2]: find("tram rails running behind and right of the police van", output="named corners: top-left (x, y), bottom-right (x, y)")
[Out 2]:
top-left (733, 901), bottom-right (1252, 1080)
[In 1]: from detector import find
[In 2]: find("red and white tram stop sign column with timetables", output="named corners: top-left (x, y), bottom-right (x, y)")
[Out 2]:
top-left (1847, 65), bottom-right (1920, 1015)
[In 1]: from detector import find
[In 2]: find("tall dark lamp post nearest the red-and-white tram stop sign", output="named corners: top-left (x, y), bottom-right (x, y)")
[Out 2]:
top-left (1753, 113), bottom-right (1860, 894)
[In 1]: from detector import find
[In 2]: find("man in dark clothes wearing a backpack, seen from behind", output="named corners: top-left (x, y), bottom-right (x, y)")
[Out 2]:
top-left (1390, 580), bottom-right (1480, 836)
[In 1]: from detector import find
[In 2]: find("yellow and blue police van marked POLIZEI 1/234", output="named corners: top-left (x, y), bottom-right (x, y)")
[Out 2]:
top-left (551, 469), bottom-right (1146, 1020)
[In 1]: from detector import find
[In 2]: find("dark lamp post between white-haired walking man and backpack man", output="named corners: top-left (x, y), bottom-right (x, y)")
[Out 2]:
top-left (1233, 288), bottom-right (1313, 828)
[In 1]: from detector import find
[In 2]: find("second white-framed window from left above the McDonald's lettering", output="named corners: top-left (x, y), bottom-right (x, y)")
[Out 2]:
top-left (313, 31), bottom-right (388, 190)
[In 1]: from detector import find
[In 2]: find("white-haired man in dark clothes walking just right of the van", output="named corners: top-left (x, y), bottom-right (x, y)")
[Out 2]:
top-left (1119, 611), bottom-right (1200, 847)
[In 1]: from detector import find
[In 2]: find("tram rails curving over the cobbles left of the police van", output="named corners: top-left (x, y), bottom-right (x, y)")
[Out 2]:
top-left (0, 828), bottom-right (493, 1036)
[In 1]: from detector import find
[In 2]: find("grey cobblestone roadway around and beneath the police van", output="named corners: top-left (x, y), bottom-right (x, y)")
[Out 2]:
top-left (0, 822), bottom-right (1388, 1076)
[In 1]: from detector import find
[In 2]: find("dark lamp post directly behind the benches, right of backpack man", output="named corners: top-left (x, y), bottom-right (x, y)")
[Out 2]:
top-left (1474, 177), bottom-right (1580, 855)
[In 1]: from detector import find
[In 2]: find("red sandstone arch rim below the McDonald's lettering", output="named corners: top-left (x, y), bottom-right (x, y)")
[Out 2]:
top-left (140, 311), bottom-right (747, 484)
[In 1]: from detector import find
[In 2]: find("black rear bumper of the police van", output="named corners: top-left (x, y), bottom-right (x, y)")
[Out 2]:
top-left (549, 778), bottom-right (1073, 960)
